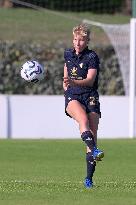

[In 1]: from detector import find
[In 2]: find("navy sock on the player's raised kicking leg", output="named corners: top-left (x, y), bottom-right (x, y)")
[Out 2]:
top-left (81, 131), bottom-right (95, 150)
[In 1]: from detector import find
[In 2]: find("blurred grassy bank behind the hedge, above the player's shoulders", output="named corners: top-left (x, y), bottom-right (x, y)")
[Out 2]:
top-left (0, 9), bottom-right (130, 45)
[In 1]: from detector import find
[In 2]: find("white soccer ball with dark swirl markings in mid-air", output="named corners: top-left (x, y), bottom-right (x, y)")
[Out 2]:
top-left (21, 60), bottom-right (44, 83)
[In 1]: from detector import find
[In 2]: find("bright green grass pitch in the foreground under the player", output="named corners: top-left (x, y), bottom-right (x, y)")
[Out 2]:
top-left (0, 139), bottom-right (136, 205)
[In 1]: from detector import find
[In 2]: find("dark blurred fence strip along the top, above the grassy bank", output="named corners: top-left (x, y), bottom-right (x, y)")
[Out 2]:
top-left (0, 0), bottom-right (132, 14)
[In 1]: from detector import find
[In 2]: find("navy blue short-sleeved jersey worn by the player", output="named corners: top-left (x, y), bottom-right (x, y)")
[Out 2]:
top-left (64, 47), bottom-right (100, 94)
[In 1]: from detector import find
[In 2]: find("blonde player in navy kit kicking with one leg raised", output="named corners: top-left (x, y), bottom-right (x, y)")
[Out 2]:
top-left (63, 24), bottom-right (104, 188)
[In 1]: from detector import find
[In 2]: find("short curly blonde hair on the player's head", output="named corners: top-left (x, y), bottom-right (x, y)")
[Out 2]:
top-left (73, 24), bottom-right (90, 40)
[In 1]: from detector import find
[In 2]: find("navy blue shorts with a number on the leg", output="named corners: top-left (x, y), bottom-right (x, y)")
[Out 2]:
top-left (64, 90), bottom-right (101, 117)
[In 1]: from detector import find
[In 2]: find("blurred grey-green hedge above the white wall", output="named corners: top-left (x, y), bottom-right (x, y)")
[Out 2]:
top-left (0, 42), bottom-right (124, 95)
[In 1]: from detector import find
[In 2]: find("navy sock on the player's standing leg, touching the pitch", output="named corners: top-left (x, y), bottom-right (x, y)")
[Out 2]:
top-left (86, 152), bottom-right (96, 180)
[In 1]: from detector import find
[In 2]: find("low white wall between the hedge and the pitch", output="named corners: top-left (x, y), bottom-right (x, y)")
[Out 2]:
top-left (0, 95), bottom-right (136, 139)
